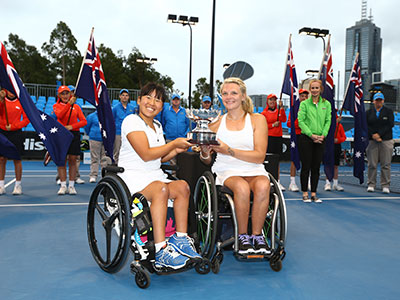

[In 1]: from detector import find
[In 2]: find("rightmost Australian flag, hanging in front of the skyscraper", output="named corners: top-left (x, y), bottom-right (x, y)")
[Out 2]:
top-left (343, 53), bottom-right (368, 184)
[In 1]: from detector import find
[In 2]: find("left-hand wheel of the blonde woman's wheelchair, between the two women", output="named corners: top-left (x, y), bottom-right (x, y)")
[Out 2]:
top-left (194, 171), bottom-right (218, 259)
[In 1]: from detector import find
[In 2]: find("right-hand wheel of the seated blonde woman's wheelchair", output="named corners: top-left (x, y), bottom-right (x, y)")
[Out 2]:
top-left (263, 175), bottom-right (287, 260)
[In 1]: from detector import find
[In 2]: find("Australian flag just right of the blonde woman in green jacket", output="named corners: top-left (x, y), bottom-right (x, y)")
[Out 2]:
top-left (319, 35), bottom-right (336, 180)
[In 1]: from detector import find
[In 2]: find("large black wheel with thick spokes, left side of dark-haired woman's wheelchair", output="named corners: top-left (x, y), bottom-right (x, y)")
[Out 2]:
top-left (87, 174), bottom-right (131, 273)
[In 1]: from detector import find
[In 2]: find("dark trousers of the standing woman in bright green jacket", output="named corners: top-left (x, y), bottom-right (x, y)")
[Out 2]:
top-left (298, 134), bottom-right (325, 193)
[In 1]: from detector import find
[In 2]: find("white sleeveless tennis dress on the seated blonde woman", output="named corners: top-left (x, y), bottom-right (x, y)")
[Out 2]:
top-left (212, 114), bottom-right (268, 185)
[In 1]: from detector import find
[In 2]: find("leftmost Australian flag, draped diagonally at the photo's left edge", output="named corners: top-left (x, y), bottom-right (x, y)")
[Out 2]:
top-left (0, 43), bottom-right (73, 166)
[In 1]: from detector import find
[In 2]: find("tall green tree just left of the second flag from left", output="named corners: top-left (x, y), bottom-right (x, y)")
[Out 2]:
top-left (42, 21), bottom-right (82, 85)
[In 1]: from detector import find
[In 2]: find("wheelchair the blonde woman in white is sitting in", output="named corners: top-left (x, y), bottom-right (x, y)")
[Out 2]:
top-left (194, 171), bottom-right (287, 274)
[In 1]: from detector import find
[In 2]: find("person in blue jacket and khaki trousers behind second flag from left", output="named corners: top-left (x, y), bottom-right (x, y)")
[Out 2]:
top-left (85, 111), bottom-right (107, 183)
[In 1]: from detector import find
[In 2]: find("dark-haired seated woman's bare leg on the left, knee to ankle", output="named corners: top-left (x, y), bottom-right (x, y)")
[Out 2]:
top-left (140, 181), bottom-right (169, 243)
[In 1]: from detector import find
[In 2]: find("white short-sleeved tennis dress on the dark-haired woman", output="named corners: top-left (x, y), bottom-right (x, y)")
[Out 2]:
top-left (118, 115), bottom-right (171, 194)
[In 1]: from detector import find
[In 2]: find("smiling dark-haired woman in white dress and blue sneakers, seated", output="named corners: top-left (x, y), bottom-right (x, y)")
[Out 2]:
top-left (119, 83), bottom-right (201, 270)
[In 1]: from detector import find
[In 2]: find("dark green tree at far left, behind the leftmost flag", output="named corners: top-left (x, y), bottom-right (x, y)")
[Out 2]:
top-left (4, 33), bottom-right (56, 83)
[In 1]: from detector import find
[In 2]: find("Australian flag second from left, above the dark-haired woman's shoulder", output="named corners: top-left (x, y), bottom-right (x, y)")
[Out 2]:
top-left (75, 30), bottom-right (115, 161)
